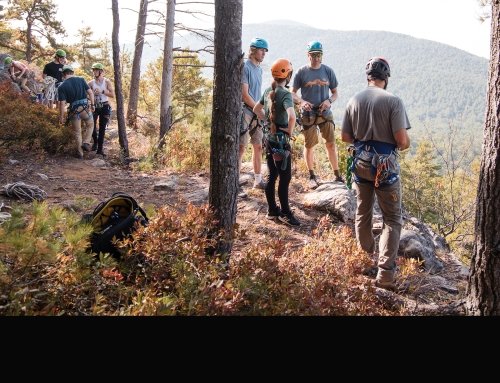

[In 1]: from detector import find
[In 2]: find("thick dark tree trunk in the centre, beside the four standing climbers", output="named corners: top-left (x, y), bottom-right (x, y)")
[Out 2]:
top-left (209, 0), bottom-right (243, 256)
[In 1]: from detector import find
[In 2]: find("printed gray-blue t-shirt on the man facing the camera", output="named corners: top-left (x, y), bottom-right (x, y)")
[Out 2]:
top-left (293, 64), bottom-right (338, 106)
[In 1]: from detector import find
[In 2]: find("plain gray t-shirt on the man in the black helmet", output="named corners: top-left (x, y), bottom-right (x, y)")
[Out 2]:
top-left (342, 86), bottom-right (411, 144)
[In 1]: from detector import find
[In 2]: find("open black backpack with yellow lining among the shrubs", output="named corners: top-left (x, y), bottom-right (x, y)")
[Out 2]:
top-left (86, 192), bottom-right (148, 258)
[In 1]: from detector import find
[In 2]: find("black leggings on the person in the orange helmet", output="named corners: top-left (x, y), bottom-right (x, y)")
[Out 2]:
top-left (266, 154), bottom-right (292, 214)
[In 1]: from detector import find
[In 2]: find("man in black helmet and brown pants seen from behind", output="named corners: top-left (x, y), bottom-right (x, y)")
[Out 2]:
top-left (342, 57), bottom-right (411, 290)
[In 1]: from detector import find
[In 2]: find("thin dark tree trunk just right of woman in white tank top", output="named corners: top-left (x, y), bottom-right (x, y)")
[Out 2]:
top-left (111, 0), bottom-right (129, 161)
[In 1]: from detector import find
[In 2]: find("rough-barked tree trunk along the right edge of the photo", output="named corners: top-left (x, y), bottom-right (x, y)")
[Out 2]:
top-left (466, 0), bottom-right (500, 315)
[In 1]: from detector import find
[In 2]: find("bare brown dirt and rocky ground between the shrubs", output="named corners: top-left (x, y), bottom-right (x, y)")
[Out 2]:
top-left (0, 132), bottom-right (466, 315)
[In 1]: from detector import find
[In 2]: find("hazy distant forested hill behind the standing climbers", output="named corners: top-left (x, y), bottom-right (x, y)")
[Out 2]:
top-left (164, 21), bottom-right (488, 148)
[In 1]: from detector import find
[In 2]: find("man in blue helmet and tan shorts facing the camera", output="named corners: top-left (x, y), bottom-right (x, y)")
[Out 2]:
top-left (292, 41), bottom-right (344, 189)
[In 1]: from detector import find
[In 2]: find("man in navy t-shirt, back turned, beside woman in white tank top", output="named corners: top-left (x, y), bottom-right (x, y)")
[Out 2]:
top-left (57, 65), bottom-right (95, 159)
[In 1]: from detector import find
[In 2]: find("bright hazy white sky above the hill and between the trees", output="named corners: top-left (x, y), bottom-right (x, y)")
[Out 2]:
top-left (54, 0), bottom-right (490, 58)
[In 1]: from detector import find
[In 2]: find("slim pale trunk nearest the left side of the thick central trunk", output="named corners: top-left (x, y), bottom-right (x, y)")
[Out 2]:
top-left (158, 0), bottom-right (175, 148)
